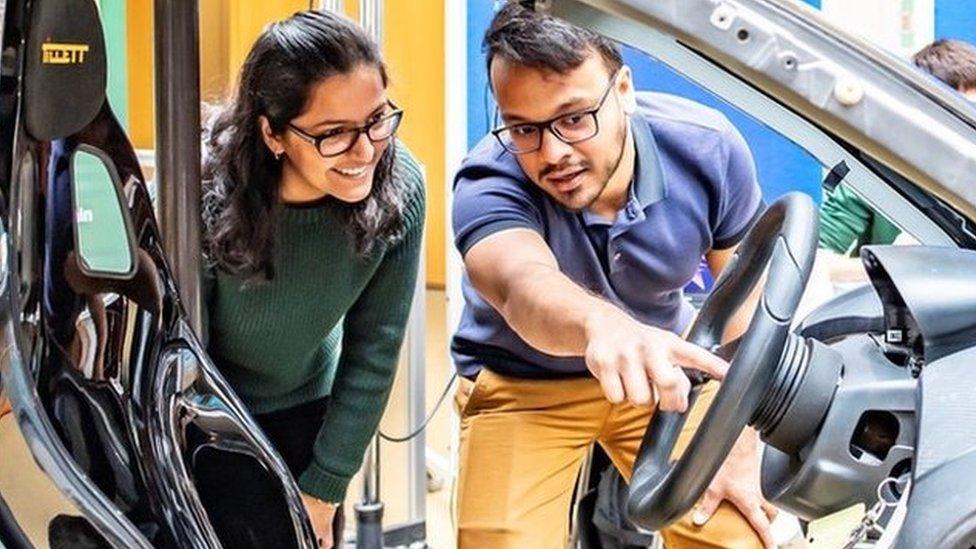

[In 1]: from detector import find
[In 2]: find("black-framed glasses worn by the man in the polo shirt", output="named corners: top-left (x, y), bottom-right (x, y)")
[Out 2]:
top-left (491, 70), bottom-right (620, 154)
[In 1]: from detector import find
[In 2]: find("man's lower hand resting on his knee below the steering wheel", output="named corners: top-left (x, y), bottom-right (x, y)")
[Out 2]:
top-left (692, 427), bottom-right (776, 549)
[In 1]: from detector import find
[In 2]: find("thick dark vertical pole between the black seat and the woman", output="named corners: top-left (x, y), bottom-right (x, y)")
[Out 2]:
top-left (154, 0), bottom-right (200, 333)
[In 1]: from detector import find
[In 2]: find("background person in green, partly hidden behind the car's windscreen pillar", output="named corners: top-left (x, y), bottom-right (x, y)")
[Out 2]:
top-left (820, 40), bottom-right (976, 284)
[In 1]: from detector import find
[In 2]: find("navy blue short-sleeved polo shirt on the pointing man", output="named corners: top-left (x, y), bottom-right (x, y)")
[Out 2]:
top-left (451, 92), bottom-right (763, 378)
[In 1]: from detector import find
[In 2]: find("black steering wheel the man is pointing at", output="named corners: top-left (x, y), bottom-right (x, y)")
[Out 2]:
top-left (627, 193), bottom-right (818, 530)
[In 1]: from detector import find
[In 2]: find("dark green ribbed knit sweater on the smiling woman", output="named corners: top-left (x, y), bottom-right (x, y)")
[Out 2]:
top-left (204, 144), bottom-right (424, 501)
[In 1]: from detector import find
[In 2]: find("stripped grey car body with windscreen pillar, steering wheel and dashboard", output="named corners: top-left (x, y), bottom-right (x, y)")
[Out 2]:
top-left (524, 0), bottom-right (976, 548)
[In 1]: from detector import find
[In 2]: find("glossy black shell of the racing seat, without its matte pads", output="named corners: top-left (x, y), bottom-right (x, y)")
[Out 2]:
top-left (0, 0), bottom-right (315, 547)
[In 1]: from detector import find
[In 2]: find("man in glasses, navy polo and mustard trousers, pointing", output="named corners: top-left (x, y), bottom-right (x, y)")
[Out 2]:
top-left (452, 3), bottom-right (772, 548)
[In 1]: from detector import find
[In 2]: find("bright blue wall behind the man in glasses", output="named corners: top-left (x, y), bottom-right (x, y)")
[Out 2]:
top-left (467, 0), bottom-right (821, 202)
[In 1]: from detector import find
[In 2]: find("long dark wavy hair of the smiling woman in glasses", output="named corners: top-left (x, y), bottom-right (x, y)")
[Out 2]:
top-left (202, 10), bottom-right (404, 283)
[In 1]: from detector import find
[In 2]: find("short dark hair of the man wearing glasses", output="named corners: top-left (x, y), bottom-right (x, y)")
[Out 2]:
top-left (482, 1), bottom-right (624, 79)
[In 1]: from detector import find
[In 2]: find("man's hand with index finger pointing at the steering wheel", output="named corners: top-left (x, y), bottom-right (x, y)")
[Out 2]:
top-left (584, 309), bottom-right (728, 412)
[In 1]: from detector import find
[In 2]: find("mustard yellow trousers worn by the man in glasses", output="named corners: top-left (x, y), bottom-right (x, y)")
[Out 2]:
top-left (455, 368), bottom-right (762, 549)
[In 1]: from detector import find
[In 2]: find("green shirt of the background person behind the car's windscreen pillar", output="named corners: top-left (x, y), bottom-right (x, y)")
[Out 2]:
top-left (820, 183), bottom-right (901, 256)
